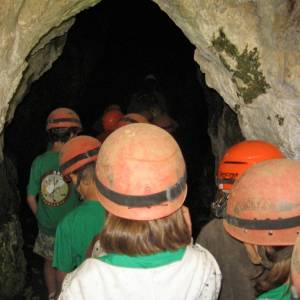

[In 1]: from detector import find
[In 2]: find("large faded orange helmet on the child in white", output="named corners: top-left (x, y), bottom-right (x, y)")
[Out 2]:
top-left (96, 123), bottom-right (187, 220)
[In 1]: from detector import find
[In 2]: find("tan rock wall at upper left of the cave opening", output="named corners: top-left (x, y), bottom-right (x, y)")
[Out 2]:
top-left (0, 0), bottom-right (100, 159)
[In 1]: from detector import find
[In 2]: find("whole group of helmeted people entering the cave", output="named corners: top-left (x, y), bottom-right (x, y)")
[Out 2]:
top-left (27, 105), bottom-right (300, 300)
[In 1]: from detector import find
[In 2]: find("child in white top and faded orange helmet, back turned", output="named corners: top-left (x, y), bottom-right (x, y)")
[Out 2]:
top-left (59, 123), bottom-right (221, 300)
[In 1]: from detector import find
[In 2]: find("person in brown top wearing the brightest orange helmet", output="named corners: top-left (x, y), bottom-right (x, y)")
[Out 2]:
top-left (196, 140), bottom-right (284, 300)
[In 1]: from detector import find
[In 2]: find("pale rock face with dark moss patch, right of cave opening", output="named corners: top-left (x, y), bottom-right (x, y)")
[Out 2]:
top-left (155, 0), bottom-right (300, 159)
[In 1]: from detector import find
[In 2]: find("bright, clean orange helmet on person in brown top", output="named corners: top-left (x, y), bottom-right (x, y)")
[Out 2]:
top-left (217, 140), bottom-right (284, 190)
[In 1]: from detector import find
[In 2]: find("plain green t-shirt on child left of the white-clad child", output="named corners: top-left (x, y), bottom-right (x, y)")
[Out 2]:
top-left (52, 200), bottom-right (106, 273)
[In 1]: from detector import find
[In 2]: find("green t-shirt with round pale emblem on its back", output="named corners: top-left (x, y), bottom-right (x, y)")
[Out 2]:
top-left (27, 151), bottom-right (80, 236)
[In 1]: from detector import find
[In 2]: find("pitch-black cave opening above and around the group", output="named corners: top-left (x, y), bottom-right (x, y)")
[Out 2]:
top-left (4, 0), bottom-right (232, 296)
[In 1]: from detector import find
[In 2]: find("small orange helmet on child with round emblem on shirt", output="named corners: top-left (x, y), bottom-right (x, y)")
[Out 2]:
top-left (46, 107), bottom-right (82, 130)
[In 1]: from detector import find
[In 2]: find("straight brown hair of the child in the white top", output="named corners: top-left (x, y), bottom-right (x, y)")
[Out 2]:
top-left (100, 208), bottom-right (191, 256)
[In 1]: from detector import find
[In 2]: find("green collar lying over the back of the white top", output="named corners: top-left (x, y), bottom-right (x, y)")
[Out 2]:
top-left (98, 248), bottom-right (186, 269)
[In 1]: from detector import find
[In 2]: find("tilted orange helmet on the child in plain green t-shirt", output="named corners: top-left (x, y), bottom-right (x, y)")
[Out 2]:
top-left (59, 135), bottom-right (101, 176)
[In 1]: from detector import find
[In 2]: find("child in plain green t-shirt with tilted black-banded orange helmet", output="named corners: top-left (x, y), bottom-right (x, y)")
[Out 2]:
top-left (52, 135), bottom-right (106, 293)
